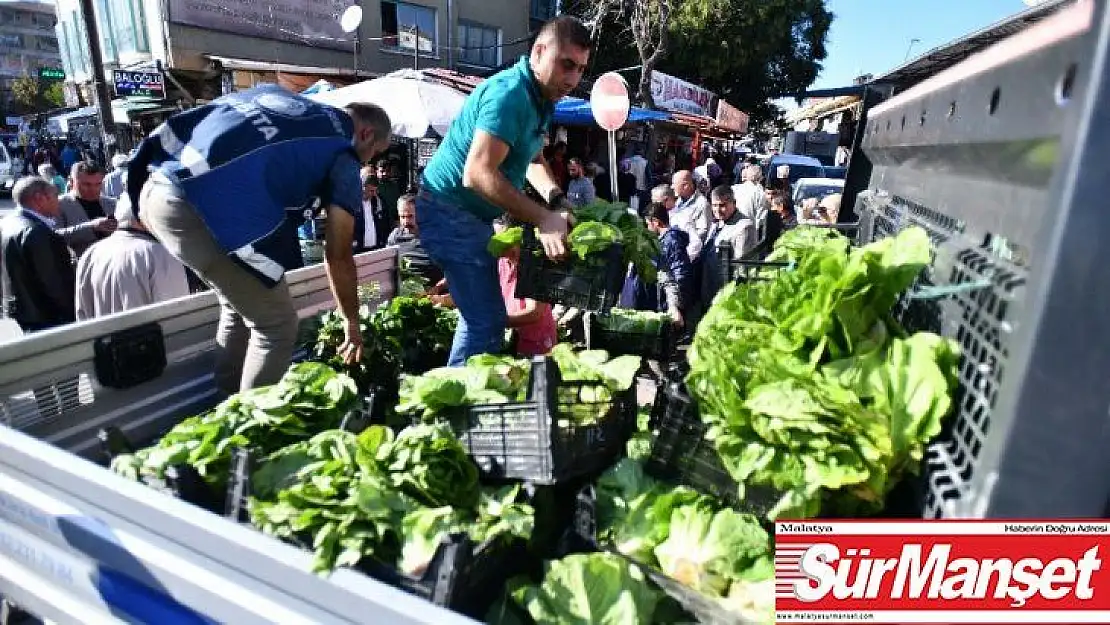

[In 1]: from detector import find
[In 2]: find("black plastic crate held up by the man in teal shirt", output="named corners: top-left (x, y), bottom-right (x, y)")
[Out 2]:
top-left (516, 225), bottom-right (627, 312)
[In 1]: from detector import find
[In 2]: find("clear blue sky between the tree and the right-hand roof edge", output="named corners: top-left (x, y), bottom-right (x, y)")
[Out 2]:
top-left (813, 0), bottom-right (1027, 89)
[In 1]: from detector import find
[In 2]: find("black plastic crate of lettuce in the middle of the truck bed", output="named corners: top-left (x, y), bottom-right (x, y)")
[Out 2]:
top-left (445, 356), bottom-right (636, 484)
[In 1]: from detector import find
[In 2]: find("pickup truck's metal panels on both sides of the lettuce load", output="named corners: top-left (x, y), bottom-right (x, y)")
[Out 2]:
top-left (0, 1), bottom-right (1110, 625)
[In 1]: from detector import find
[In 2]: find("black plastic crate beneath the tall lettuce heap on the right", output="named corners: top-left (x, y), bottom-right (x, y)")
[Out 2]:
top-left (645, 382), bottom-right (779, 516)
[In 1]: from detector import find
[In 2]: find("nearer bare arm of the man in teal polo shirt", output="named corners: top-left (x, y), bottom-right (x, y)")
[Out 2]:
top-left (463, 130), bottom-right (569, 259)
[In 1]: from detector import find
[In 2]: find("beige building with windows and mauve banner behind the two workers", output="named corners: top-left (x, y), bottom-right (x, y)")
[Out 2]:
top-left (56, 0), bottom-right (556, 102)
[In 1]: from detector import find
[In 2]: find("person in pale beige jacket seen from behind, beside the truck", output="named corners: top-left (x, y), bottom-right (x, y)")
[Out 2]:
top-left (74, 193), bottom-right (190, 321)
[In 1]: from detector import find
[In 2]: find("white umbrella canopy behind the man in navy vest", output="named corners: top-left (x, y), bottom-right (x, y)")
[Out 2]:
top-left (309, 70), bottom-right (466, 139)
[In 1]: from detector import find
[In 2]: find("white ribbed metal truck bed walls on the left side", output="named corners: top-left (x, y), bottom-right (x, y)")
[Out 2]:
top-left (0, 249), bottom-right (471, 625)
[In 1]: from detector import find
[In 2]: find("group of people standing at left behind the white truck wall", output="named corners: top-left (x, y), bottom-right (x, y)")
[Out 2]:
top-left (0, 155), bottom-right (191, 333)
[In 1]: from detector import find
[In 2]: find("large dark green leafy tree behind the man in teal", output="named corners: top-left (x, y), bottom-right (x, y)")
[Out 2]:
top-left (563, 0), bottom-right (833, 125)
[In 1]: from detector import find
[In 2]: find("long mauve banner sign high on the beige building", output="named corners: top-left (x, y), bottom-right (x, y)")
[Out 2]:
top-left (170, 0), bottom-right (355, 50)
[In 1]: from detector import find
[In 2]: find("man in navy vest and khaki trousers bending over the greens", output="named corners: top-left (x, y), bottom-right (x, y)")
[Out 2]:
top-left (127, 84), bottom-right (391, 393)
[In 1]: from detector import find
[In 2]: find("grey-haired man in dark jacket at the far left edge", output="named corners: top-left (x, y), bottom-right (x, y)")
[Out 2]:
top-left (0, 175), bottom-right (77, 332)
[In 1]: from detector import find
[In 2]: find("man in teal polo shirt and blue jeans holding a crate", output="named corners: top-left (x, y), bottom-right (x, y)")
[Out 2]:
top-left (416, 17), bottom-right (589, 366)
